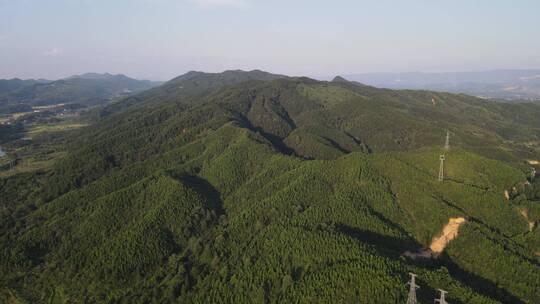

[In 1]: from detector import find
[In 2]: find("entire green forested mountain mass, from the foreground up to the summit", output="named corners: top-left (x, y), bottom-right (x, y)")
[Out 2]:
top-left (0, 71), bottom-right (540, 303)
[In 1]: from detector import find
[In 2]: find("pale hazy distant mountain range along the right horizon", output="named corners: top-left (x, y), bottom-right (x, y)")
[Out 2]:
top-left (344, 70), bottom-right (540, 100)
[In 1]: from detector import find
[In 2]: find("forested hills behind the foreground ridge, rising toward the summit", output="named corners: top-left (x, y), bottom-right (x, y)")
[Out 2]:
top-left (70, 76), bottom-right (540, 177)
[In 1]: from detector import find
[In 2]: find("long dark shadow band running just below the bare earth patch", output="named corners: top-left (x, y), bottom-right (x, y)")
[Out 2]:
top-left (336, 224), bottom-right (524, 303)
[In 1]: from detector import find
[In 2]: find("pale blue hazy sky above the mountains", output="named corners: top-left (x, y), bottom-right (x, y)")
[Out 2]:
top-left (0, 0), bottom-right (540, 80)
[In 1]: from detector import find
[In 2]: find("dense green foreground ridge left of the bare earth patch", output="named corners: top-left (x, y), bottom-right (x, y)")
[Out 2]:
top-left (3, 124), bottom-right (528, 303)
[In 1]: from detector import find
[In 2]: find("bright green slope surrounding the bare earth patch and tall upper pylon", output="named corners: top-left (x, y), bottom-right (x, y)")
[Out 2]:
top-left (375, 148), bottom-right (540, 302)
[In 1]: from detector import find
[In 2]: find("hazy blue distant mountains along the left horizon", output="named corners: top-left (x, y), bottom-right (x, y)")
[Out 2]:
top-left (0, 73), bottom-right (161, 112)
